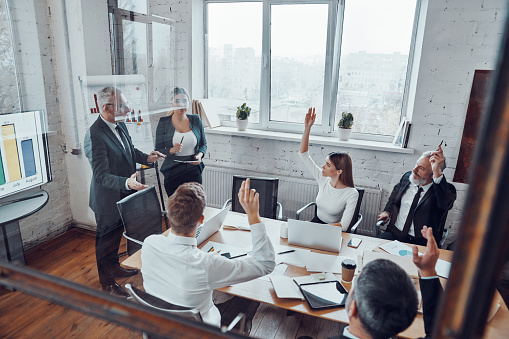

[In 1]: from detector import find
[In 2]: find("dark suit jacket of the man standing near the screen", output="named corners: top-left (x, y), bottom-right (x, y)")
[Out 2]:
top-left (84, 116), bottom-right (148, 215)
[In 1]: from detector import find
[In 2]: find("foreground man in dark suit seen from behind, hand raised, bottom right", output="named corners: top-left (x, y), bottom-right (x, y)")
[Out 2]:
top-left (334, 226), bottom-right (442, 339)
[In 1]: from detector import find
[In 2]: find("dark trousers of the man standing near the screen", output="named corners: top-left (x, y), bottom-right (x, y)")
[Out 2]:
top-left (95, 213), bottom-right (124, 286)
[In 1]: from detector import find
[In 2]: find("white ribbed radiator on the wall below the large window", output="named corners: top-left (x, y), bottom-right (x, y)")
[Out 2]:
top-left (203, 166), bottom-right (382, 236)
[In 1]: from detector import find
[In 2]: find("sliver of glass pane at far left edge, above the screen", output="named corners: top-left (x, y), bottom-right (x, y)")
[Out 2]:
top-left (0, 0), bottom-right (21, 113)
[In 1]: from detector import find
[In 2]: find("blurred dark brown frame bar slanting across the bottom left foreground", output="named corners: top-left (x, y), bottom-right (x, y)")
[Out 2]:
top-left (0, 261), bottom-right (247, 339)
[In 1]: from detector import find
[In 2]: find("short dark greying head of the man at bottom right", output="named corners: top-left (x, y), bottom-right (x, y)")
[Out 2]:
top-left (350, 259), bottom-right (418, 339)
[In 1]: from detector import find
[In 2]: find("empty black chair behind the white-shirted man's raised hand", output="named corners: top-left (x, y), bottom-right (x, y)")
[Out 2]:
top-left (223, 175), bottom-right (283, 220)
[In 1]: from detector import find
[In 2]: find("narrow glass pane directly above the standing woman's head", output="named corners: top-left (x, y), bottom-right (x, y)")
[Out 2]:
top-left (151, 22), bottom-right (175, 107)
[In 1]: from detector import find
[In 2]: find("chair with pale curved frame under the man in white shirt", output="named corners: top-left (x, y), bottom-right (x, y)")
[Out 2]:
top-left (125, 284), bottom-right (245, 338)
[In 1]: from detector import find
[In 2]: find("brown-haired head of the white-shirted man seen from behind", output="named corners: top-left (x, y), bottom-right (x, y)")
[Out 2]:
top-left (168, 182), bottom-right (205, 235)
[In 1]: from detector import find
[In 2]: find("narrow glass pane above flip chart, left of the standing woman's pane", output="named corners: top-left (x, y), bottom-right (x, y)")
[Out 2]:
top-left (122, 20), bottom-right (148, 75)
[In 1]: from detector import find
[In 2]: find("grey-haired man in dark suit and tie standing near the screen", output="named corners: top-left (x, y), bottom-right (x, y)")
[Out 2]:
top-left (84, 87), bottom-right (164, 297)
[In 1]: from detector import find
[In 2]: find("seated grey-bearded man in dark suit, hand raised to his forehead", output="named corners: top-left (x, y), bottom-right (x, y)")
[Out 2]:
top-left (377, 146), bottom-right (456, 246)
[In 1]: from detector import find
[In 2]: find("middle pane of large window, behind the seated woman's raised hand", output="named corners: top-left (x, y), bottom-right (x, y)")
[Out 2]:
top-left (270, 4), bottom-right (328, 123)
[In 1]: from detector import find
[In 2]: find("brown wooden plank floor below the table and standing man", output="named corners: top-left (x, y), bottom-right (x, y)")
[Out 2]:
top-left (0, 228), bottom-right (342, 339)
